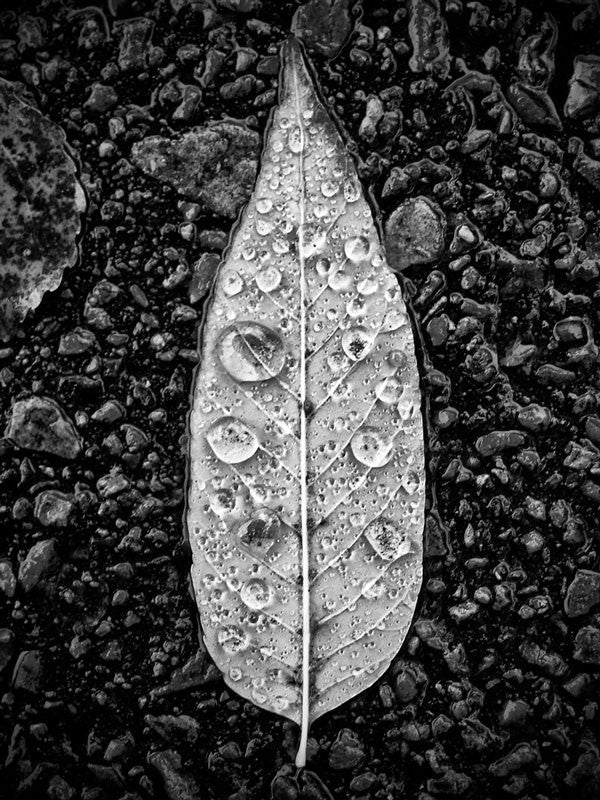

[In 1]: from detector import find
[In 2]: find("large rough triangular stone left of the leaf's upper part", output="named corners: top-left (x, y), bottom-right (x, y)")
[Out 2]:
top-left (131, 122), bottom-right (260, 219)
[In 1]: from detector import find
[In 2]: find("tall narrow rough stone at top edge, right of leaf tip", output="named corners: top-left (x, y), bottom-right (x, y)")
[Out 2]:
top-left (408, 0), bottom-right (451, 80)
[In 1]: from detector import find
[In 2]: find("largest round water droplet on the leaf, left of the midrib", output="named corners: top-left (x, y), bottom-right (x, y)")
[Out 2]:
top-left (217, 322), bottom-right (285, 382)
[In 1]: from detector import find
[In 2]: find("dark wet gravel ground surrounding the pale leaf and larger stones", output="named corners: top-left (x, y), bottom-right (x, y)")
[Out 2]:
top-left (0, 0), bottom-right (600, 800)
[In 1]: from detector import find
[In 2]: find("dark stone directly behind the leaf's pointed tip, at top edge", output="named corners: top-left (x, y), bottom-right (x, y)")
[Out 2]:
top-left (292, 0), bottom-right (352, 58)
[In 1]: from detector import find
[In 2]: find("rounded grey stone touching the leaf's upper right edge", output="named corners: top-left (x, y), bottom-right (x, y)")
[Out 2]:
top-left (385, 197), bottom-right (446, 270)
